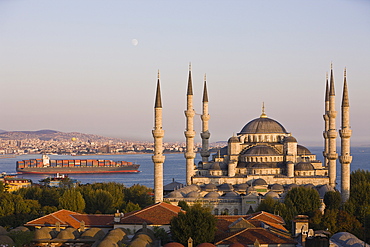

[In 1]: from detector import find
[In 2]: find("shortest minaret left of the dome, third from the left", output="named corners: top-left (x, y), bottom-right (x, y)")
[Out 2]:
top-left (200, 75), bottom-right (211, 163)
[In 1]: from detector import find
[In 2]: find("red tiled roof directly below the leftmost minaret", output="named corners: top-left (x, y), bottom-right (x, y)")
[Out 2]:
top-left (120, 202), bottom-right (182, 225)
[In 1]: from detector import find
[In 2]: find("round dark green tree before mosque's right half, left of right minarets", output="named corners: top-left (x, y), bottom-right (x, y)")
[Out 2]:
top-left (284, 187), bottom-right (320, 216)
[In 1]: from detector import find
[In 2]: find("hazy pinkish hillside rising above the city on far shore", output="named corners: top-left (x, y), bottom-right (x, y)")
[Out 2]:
top-left (0, 130), bottom-right (123, 142)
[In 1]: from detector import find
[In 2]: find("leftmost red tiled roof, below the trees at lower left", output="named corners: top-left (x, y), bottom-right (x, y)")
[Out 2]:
top-left (25, 209), bottom-right (114, 228)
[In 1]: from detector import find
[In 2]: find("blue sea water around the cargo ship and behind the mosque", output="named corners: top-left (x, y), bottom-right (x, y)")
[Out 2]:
top-left (0, 147), bottom-right (370, 189)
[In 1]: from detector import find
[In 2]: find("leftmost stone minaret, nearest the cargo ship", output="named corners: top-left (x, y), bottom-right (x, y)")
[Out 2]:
top-left (152, 71), bottom-right (165, 203)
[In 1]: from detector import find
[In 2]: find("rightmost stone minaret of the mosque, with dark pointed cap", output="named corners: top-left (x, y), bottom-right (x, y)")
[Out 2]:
top-left (339, 69), bottom-right (352, 202)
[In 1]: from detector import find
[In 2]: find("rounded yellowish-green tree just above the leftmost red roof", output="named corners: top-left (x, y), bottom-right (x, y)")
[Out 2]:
top-left (59, 189), bottom-right (85, 213)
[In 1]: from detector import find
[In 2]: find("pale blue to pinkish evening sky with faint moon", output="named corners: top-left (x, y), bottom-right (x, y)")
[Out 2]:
top-left (0, 0), bottom-right (370, 145)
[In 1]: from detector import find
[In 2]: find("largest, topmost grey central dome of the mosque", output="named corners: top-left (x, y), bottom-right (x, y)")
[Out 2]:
top-left (238, 117), bottom-right (288, 135)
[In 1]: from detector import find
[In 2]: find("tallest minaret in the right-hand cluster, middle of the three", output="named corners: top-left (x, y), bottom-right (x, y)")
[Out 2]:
top-left (326, 65), bottom-right (338, 188)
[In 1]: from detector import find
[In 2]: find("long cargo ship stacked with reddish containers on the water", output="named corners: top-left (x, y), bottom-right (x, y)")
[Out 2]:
top-left (16, 155), bottom-right (140, 174)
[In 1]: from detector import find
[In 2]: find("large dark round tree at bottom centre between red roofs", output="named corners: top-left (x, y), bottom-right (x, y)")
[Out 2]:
top-left (170, 204), bottom-right (216, 246)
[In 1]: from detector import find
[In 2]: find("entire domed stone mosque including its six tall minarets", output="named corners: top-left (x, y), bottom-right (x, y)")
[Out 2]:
top-left (152, 64), bottom-right (352, 215)
